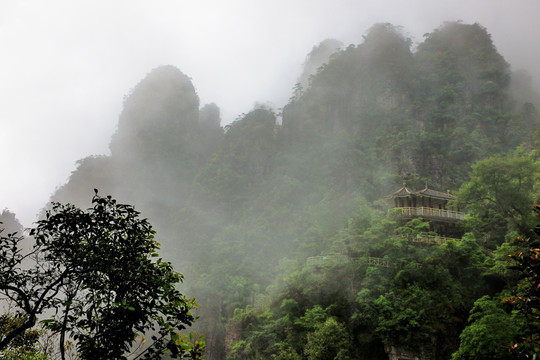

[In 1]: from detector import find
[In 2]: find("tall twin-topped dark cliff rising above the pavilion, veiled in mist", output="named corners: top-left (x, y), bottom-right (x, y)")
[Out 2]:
top-left (283, 23), bottom-right (538, 187)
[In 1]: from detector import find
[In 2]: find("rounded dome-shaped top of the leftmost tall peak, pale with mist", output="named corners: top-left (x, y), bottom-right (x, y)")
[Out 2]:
top-left (110, 66), bottom-right (200, 169)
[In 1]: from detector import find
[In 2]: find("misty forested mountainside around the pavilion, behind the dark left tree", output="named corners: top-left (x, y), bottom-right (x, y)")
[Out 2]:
top-left (5, 22), bottom-right (540, 360)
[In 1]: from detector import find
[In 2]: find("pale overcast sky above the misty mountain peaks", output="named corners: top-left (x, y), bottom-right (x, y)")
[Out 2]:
top-left (0, 0), bottom-right (540, 226)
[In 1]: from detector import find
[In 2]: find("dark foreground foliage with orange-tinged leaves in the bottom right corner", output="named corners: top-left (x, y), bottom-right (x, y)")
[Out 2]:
top-left (452, 205), bottom-right (540, 360)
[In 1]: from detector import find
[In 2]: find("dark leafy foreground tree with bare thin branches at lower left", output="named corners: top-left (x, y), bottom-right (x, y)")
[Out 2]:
top-left (0, 190), bottom-right (204, 359)
